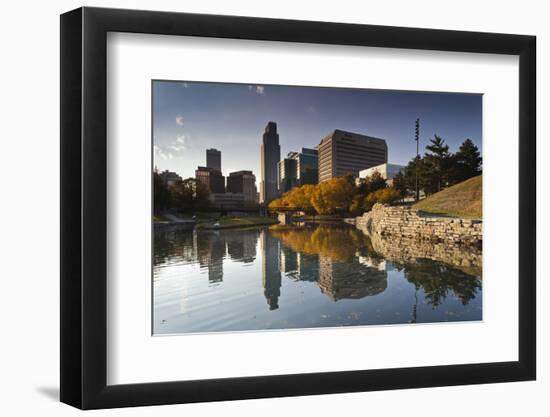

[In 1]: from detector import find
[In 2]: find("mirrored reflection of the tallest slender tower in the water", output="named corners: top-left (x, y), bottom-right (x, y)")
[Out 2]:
top-left (260, 229), bottom-right (281, 310)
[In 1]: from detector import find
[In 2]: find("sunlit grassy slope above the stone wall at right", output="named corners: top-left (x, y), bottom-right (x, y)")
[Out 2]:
top-left (413, 175), bottom-right (482, 219)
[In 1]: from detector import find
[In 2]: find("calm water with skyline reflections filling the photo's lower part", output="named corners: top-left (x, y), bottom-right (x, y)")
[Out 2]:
top-left (153, 223), bottom-right (482, 334)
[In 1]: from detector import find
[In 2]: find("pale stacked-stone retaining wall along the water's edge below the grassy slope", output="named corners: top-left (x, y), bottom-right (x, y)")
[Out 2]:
top-left (355, 204), bottom-right (483, 247)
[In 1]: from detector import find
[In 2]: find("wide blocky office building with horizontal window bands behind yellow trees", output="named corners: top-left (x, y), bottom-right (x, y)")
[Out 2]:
top-left (318, 130), bottom-right (388, 182)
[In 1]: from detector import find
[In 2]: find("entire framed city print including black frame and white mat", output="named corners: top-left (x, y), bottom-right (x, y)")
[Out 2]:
top-left (61, 8), bottom-right (536, 409)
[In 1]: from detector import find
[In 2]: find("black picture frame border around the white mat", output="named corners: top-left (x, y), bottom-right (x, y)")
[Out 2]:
top-left (60, 7), bottom-right (536, 409)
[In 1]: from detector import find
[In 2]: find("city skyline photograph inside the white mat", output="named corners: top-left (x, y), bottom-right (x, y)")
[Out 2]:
top-left (153, 80), bottom-right (483, 335)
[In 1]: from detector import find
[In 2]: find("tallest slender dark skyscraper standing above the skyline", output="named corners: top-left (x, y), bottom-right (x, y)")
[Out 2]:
top-left (260, 122), bottom-right (281, 204)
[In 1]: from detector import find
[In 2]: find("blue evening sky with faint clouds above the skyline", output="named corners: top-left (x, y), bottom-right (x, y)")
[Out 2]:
top-left (152, 81), bottom-right (482, 183)
